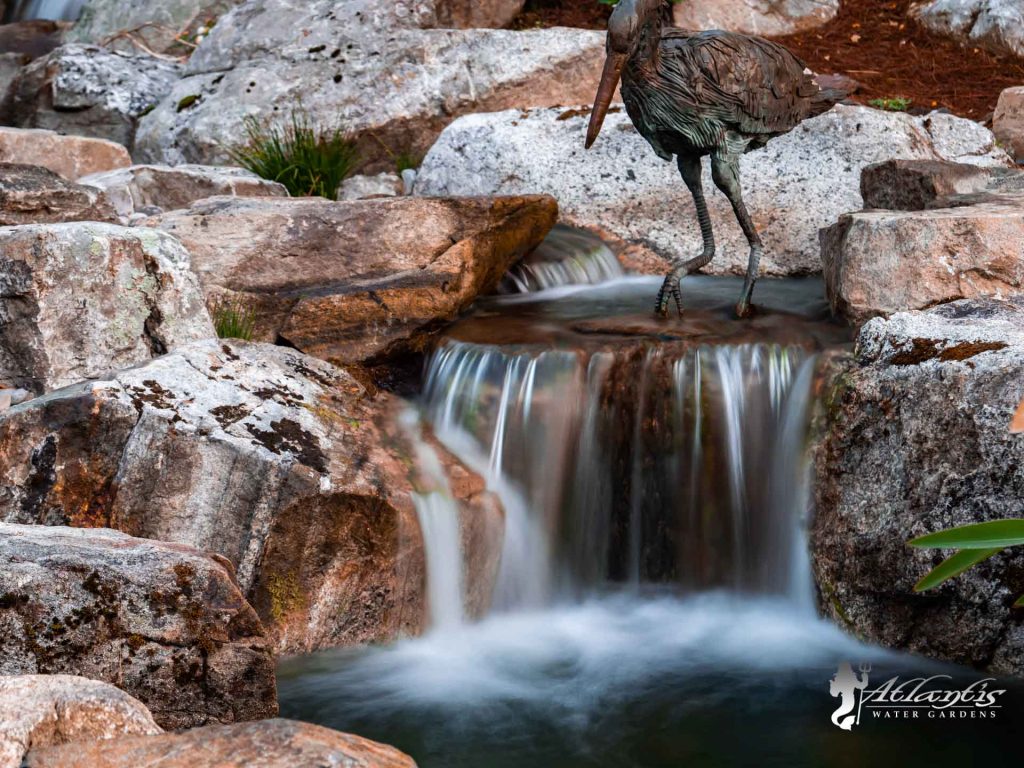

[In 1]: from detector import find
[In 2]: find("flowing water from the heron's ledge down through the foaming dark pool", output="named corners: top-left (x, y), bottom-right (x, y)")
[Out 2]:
top-left (279, 232), bottom-right (1024, 768)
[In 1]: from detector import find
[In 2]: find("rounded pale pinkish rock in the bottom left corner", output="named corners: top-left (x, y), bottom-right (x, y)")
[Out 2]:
top-left (0, 675), bottom-right (163, 768)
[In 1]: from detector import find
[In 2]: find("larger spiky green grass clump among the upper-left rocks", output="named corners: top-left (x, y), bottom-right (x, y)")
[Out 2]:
top-left (228, 112), bottom-right (358, 200)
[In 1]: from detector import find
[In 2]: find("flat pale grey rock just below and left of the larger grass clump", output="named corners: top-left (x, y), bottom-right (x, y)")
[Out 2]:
top-left (79, 165), bottom-right (288, 221)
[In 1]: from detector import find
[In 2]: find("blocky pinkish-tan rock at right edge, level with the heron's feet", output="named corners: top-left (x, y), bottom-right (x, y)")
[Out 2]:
top-left (821, 196), bottom-right (1024, 323)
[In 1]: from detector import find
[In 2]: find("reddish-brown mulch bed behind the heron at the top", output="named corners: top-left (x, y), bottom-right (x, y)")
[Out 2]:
top-left (513, 0), bottom-right (1024, 121)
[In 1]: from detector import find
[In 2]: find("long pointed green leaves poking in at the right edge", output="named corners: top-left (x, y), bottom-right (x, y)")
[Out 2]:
top-left (909, 518), bottom-right (1024, 607)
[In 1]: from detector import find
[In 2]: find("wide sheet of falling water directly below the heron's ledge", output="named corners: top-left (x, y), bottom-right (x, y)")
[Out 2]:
top-left (424, 341), bottom-right (814, 609)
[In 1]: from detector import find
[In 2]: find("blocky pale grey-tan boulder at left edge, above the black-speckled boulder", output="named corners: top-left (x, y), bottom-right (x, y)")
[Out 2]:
top-left (0, 222), bottom-right (215, 393)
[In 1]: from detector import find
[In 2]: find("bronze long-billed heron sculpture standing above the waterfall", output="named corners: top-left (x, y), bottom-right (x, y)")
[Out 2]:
top-left (587, 0), bottom-right (847, 317)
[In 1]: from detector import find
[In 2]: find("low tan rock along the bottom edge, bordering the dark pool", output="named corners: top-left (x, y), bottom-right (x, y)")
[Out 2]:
top-left (26, 720), bottom-right (416, 768)
